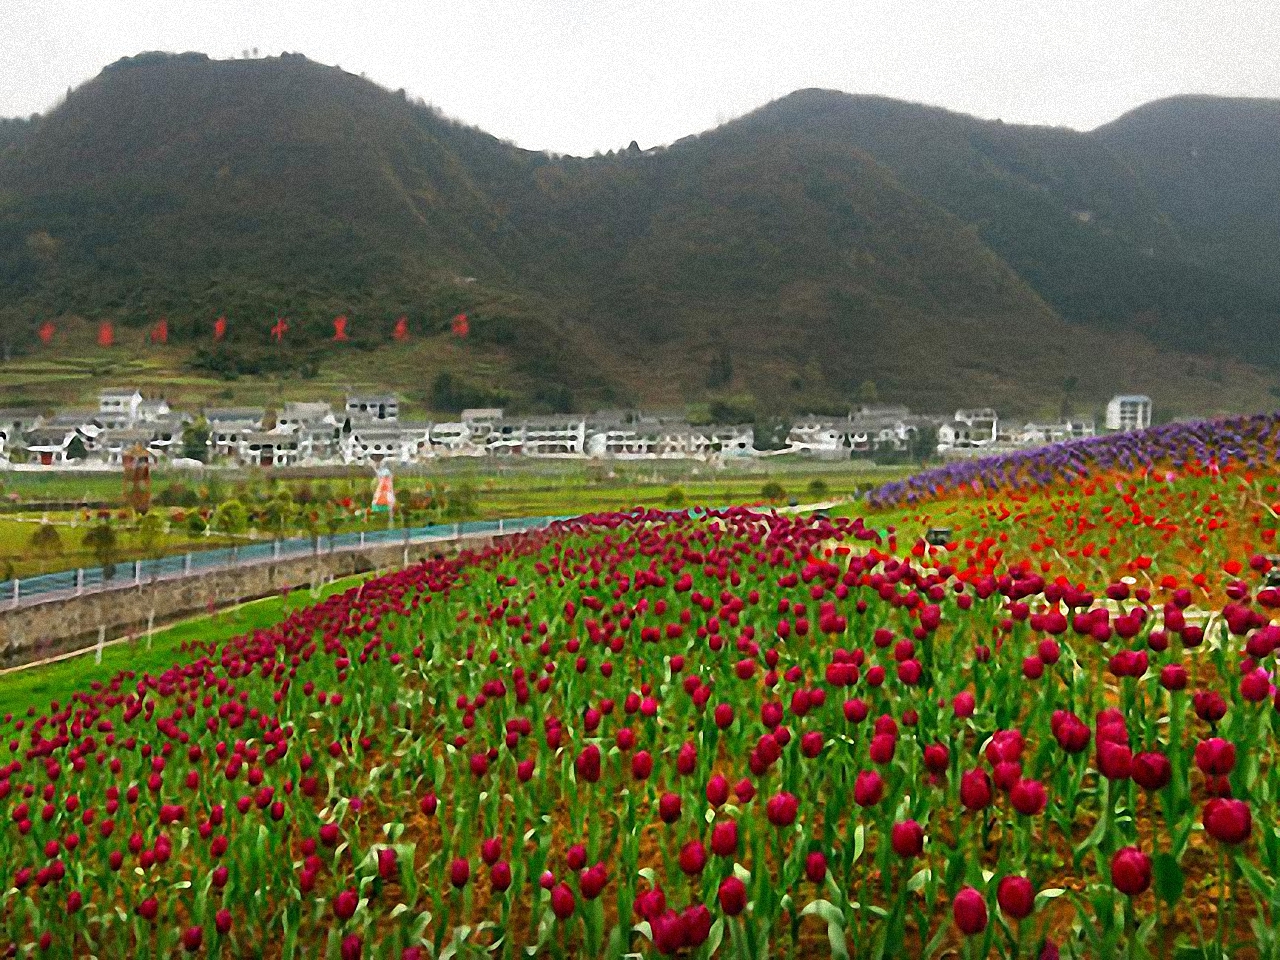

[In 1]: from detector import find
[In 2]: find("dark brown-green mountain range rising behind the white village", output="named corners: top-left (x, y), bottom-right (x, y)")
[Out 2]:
top-left (0, 54), bottom-right (1280, 416)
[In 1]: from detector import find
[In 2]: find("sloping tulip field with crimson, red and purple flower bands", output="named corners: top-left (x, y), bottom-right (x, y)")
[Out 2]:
top-left (0, 416), bottom-right (1280, 960)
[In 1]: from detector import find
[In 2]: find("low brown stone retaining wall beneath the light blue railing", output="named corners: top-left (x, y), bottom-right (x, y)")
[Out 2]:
top-left (0, 536), bottom-right (493, 668)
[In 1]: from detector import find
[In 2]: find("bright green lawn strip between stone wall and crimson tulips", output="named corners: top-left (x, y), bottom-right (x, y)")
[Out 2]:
top-left (0, 576), bottom-right (365, 716)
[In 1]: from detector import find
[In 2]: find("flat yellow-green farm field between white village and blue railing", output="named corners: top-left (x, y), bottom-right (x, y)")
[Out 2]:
top-left (0, 461), bottom-right (908, 581)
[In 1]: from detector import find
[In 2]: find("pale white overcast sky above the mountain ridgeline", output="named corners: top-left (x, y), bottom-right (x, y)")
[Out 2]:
top-left (0, 0), bottom-right (1280, 154)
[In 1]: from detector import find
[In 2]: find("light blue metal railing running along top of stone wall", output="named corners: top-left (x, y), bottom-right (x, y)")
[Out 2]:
top-left (0, 517), bottom-right (563, 607)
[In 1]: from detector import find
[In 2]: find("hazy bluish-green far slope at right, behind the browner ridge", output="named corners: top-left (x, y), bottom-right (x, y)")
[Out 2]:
top-left (741, 91), bottom-right (1280, 366)
